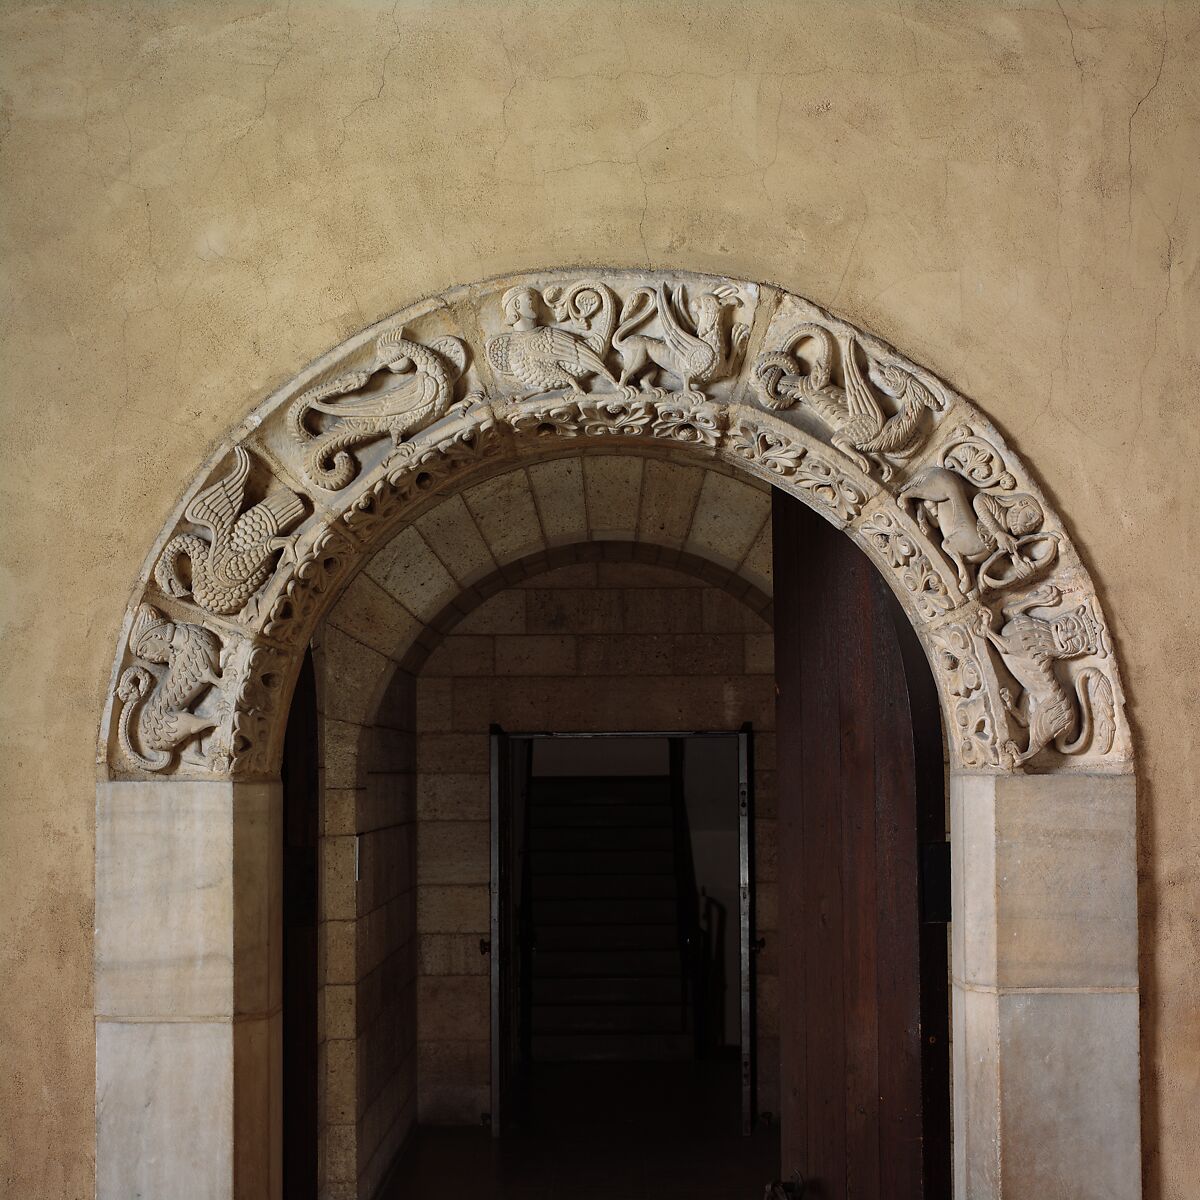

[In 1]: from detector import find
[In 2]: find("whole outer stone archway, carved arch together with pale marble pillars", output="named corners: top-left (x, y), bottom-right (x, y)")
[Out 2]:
top-left (96, 270), bottom-right (1139, 1196)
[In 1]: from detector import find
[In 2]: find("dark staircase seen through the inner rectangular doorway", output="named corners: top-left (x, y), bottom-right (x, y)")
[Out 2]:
top-left (524, 776), bottom-right (694, 1062)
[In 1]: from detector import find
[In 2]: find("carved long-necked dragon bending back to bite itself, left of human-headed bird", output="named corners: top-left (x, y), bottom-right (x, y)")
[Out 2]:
top-left (288, 330), bottom-right (467, 492)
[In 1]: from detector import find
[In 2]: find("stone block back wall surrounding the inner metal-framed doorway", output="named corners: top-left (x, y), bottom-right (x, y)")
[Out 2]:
top-left (416, 556), bottom-right (779, 1124)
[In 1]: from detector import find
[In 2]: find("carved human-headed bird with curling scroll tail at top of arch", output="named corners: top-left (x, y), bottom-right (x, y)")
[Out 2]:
top-left (487, 281), bottom-right (616, 395)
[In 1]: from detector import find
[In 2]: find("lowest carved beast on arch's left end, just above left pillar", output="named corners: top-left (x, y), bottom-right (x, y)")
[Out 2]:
top-left (116, 604), bottom-right (221, 770)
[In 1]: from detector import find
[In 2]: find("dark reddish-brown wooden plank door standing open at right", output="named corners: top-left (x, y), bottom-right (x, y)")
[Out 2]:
top-left (773, 491), bottom-right (950, 1200)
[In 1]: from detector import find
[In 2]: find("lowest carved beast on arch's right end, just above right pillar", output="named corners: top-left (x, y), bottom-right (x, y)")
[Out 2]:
top-left (982, 583), bottom-right (1116, 763)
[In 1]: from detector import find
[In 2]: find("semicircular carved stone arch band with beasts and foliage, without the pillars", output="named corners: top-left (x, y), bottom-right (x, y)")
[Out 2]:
top-left (100, 269), bottom-right (1132, 779)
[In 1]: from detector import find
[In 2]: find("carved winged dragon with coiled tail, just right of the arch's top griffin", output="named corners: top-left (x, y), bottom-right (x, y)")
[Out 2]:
top-left (754, 323), bottom-right (946, 481)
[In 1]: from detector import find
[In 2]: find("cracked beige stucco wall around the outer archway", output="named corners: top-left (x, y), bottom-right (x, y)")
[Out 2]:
top-left (0, 0), bottom-right (1200, 1200)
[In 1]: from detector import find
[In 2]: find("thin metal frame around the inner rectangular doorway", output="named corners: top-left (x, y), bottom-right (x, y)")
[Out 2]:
top-left (487, 721), bottom-right (756, 1138)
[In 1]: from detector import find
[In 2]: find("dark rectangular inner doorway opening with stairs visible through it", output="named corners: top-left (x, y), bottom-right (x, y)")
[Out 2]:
top-left (492, 730), bottom-right (754, 1136)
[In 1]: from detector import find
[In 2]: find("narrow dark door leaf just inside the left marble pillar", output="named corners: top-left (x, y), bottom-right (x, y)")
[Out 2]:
top-left (282, 654), bottom-right (319, 1200)
